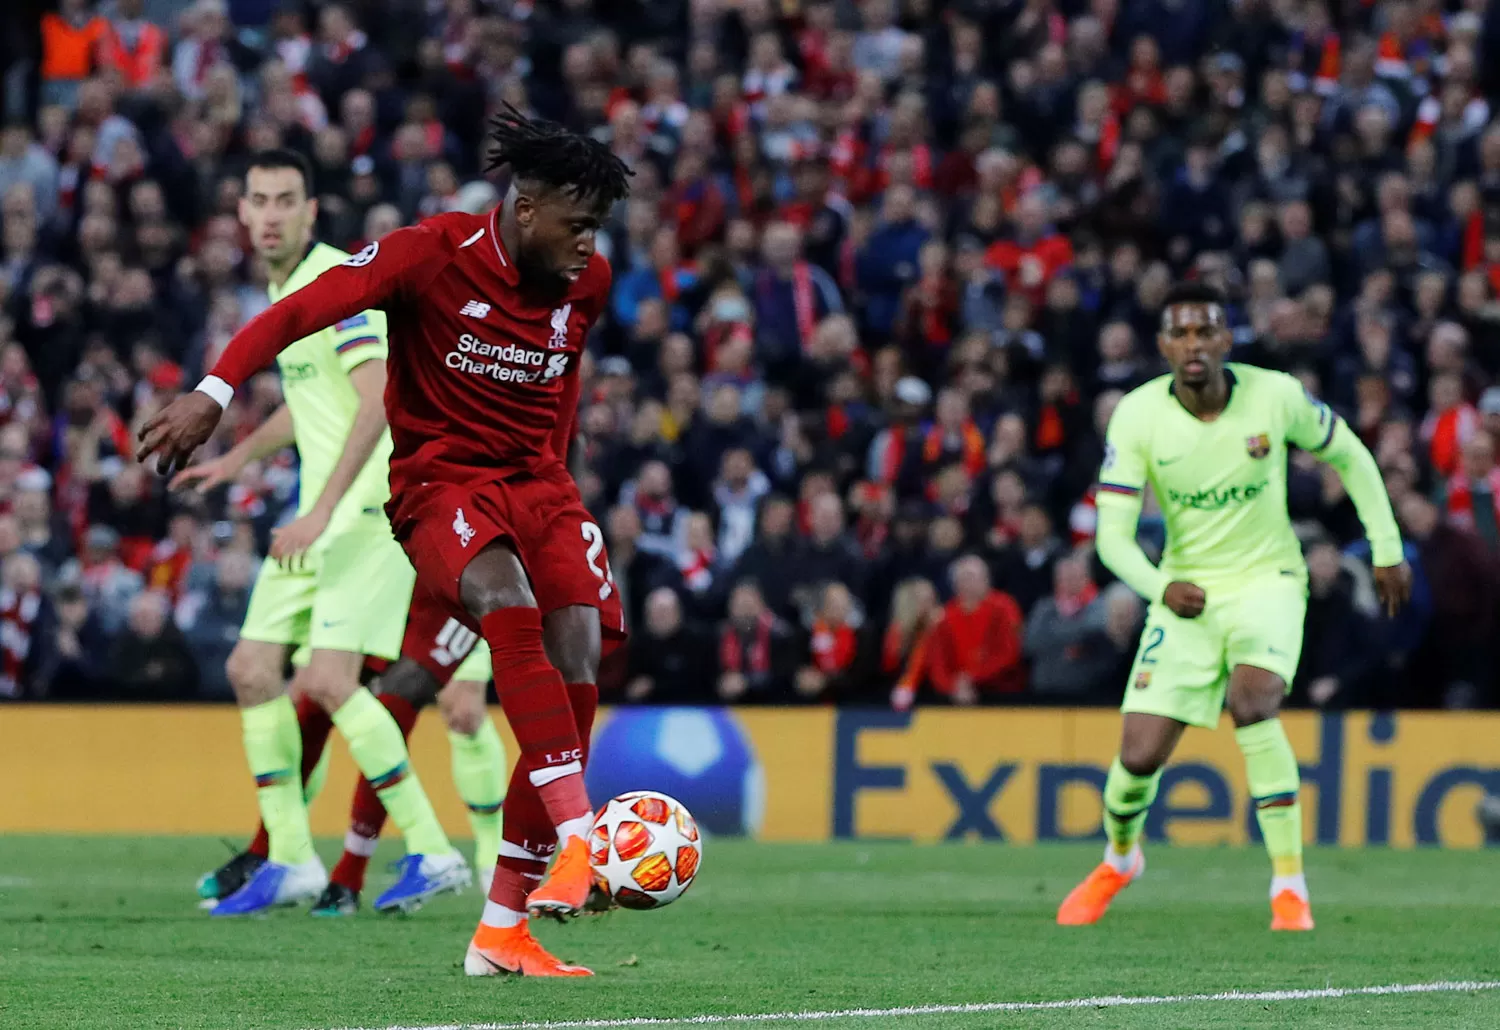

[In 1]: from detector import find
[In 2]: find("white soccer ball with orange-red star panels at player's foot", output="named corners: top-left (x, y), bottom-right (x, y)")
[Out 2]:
top-left (588, 790), bottom-right (704, 909)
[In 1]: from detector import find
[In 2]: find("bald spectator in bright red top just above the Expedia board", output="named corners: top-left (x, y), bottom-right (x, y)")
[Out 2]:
top-left (927, 555), bottom-right (1026, 705)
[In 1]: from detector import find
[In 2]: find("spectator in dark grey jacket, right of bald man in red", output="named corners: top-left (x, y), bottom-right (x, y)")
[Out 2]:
top-left (1025, 555), bottom-right (1128, 703)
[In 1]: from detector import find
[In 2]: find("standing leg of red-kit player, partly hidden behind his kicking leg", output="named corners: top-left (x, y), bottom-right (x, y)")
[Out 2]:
top-left (464, 606), bottom-right (600, 976)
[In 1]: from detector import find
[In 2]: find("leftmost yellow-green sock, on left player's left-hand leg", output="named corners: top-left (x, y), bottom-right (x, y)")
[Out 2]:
top-left (240, 696), bottom-right (317, 865)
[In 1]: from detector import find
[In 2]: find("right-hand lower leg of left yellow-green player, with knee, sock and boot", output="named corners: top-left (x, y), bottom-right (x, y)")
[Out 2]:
top-left (293, 649), bottom-right (470, 905)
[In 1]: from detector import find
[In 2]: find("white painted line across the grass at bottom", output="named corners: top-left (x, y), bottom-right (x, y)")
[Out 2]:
top-left (348, 981), bottom-right (1500, 1030)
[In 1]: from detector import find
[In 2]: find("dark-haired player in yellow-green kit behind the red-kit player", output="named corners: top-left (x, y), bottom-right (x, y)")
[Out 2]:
top-left (187, 151), bottom-right (471, 916)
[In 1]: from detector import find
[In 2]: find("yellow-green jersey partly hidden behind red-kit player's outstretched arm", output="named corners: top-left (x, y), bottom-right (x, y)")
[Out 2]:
top-left (269, 243), bottom-right (392, 535)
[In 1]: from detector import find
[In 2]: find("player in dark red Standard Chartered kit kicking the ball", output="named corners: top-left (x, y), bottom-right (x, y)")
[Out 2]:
top-left (138, 109), bottom-right (630, 976)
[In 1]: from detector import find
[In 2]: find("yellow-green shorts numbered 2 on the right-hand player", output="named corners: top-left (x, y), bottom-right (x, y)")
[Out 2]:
top-left (1121, 574), bottom-right (1308, 729)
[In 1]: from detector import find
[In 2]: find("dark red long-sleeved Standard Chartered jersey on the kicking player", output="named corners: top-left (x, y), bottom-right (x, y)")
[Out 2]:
top-left (213, 208), bottom-right (611, 504)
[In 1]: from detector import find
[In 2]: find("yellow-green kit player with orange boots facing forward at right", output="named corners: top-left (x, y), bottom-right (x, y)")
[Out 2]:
top-left (1058, 283), bottom-right (1412, 930)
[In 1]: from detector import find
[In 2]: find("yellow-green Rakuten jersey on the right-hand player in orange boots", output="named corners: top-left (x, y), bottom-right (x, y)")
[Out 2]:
top-left (1097, 364), bottom-right (1338, 588)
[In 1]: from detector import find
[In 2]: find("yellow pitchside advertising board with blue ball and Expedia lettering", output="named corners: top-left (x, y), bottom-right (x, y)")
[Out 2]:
top-left (0, 705), bottom-right (1500, 847)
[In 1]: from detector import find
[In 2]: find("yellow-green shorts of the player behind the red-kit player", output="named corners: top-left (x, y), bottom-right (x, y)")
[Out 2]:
top-left (240, 513), bottom-right (417, 661)
